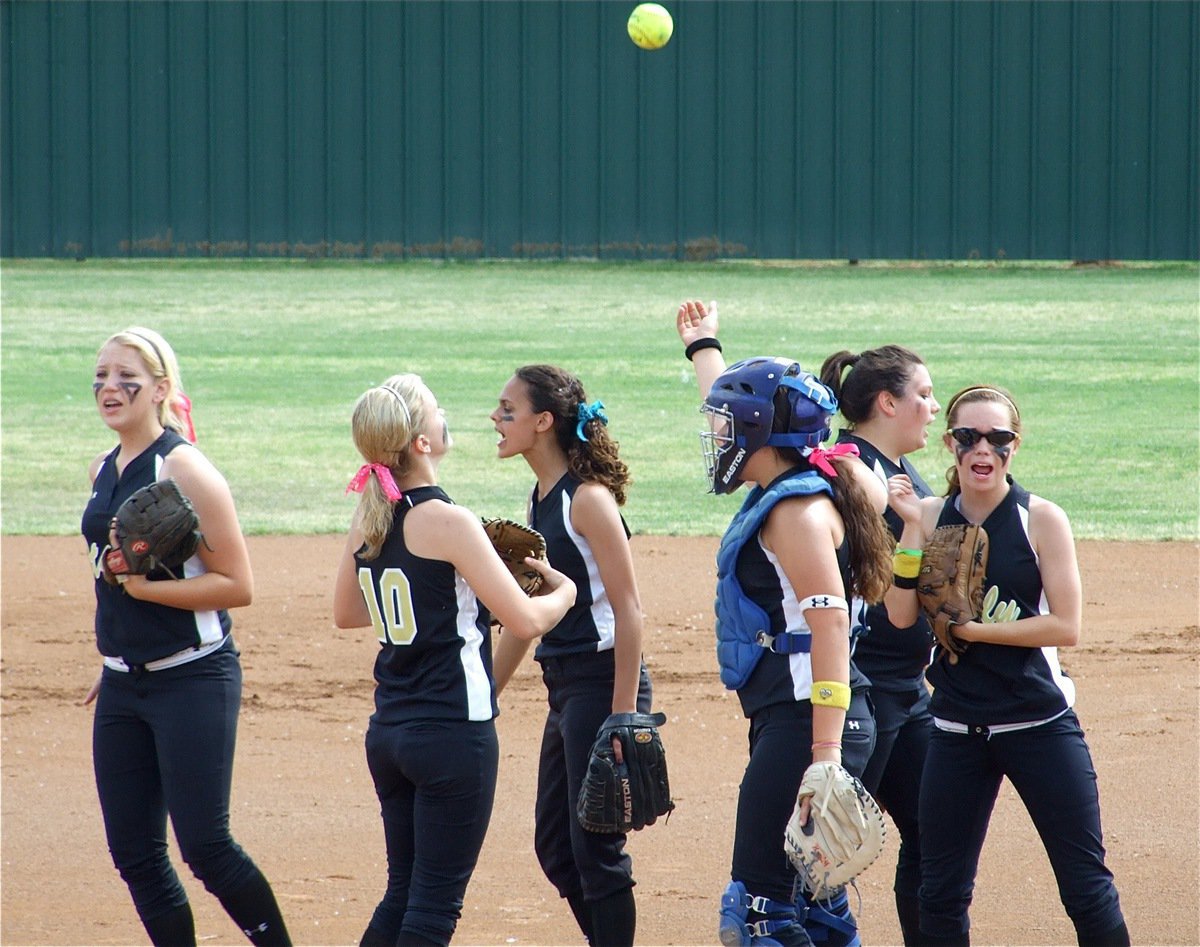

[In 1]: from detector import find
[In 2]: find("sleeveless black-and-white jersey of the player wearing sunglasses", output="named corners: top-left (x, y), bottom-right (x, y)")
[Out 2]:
top-left (928, 478), bottom-right (1075, 729)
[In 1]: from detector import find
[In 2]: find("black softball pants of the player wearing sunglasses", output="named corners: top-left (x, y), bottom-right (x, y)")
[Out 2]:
top-left (920, 711), bottom-right (1124, 943)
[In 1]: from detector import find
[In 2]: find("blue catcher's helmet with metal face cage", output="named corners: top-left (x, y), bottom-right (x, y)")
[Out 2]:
top-left (700, 355), bottom-right (838, 493)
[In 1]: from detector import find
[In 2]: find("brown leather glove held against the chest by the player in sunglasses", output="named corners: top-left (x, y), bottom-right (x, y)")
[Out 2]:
top-left (917, 523), bottom-right (988, 664)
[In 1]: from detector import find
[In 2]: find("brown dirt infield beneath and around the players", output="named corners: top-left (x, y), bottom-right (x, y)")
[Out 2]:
top-left (0, 537), bottom-right (1200, 945)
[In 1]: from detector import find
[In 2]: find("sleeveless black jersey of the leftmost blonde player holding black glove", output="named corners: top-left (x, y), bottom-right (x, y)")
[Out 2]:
top-left (82, 430), bottom-right (233, 670)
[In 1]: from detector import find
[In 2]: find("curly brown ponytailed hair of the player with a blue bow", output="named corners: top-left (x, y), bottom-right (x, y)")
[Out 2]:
top-left (516, 365), bottom-right (632, 505)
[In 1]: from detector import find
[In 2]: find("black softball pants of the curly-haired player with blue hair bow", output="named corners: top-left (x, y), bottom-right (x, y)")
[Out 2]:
top-left (534, 651), bottom-right (652, 901)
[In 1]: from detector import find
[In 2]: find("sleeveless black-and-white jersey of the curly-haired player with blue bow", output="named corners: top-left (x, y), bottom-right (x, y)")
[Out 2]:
top-left (529, 473), bottom-right (629, 661)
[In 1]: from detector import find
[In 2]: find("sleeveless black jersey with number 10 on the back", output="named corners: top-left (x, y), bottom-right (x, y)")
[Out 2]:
top-left (354, 486), bottom-right (499, 724)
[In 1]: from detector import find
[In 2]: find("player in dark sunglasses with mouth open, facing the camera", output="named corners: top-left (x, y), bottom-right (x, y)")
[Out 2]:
top-left (886, 385), bottom-right (1129, 947)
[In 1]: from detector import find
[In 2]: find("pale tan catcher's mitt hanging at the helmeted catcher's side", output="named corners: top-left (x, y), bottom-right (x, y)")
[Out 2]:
top-left (784, 762), bottom-right (887, 900)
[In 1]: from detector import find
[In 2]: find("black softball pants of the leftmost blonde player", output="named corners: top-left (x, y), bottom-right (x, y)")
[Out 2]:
top-left (92, 645), bottom-right (274, 923)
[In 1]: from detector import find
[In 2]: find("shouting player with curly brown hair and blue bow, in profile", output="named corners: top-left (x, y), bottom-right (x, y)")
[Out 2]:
top-left (491, 365), bottom-right (652, 947)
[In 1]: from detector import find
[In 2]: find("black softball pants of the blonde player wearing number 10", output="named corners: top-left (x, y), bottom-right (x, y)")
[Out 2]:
top-left (366, 720), bottom-right (500, 945)
